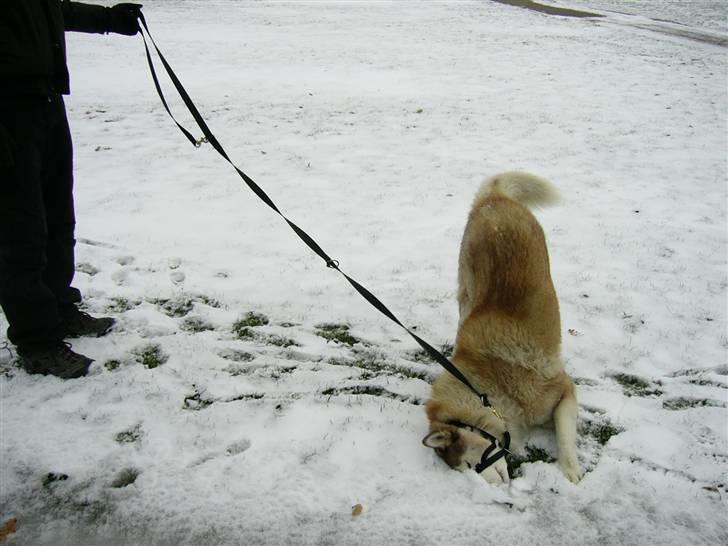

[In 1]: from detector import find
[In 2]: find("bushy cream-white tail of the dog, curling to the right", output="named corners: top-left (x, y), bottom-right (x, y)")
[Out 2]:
top-left (475, 171), bottom-right (559, 207)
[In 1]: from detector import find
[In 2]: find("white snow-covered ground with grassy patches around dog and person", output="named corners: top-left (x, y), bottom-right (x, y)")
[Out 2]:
top-left (0, 0), bottom-right (728, 546)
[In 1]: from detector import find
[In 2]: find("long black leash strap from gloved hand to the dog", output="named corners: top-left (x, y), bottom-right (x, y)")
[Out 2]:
top-left (139, 13), bottom-right (491, 406)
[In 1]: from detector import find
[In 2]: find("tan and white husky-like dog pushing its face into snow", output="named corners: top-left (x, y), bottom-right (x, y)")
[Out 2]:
top-left (422, 171), bottom-right (582, 484)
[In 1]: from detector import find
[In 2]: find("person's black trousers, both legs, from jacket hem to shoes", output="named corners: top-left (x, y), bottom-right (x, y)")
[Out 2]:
top-left (0, 97), bottom-right (80, 350)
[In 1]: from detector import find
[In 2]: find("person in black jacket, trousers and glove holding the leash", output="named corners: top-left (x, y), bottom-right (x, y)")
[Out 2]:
top-left (0, 0), bottom-right (141, 379)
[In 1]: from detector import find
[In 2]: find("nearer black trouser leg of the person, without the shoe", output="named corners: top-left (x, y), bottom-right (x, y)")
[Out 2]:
top-left (0, 99), bottom-right (61, 351)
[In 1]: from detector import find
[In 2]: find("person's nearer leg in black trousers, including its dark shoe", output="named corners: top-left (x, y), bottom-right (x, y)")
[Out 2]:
top-left (0, 99), bottom-right (93, 379)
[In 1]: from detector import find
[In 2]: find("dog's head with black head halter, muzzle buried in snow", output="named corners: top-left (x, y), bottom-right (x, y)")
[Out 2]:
top-left (422, 425), bottom-right (509, 485)
